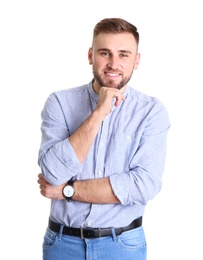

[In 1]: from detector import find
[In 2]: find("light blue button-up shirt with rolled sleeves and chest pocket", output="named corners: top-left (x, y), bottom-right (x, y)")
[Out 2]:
top-left (39, 81), bottom-right (170, 228)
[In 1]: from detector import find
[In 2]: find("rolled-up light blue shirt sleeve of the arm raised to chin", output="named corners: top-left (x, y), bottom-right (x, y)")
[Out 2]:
top-left (38, 93), bottom-right (82, 185)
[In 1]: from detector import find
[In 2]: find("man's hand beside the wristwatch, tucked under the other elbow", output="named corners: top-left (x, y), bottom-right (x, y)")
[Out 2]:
top-left (37, 173), bottom-right (66, 200)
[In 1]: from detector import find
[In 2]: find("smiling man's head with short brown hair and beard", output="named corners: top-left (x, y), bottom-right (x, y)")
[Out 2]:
top-left (88, 18), bottom-right (140, 93)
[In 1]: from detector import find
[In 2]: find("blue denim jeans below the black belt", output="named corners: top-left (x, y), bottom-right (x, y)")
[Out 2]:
top-left (43, 226), bottom-right (147, 260)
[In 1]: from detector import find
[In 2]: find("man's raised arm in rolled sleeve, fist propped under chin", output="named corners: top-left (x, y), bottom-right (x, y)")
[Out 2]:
top-left (38, 87), bottom-right (124, 185)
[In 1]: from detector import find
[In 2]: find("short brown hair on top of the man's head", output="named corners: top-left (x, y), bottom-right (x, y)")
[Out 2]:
top-left (93, 18), bottom-right (139, 44)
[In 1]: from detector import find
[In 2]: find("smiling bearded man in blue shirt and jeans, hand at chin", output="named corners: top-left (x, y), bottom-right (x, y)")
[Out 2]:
top-left (38, 18), bottom-right (170, 260)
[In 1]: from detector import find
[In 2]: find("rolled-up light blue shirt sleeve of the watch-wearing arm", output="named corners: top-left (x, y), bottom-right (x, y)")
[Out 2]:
top-left (110, 102), bottom-right (170, 205)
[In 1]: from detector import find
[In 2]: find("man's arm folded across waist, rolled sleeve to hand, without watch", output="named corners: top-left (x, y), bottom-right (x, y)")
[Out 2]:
top-left (38, 109), bottom-right (169, 205)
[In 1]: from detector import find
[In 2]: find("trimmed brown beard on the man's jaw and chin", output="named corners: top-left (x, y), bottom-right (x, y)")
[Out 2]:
top-left (93, 68), bottom-right (133, 89)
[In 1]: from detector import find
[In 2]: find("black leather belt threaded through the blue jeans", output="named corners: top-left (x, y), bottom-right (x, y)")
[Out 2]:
top-left (48, 217), bottom-right (142, 239)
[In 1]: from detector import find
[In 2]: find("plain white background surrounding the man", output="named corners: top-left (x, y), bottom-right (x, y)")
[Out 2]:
top-left (0, 0), bottom-right (203, 260)
